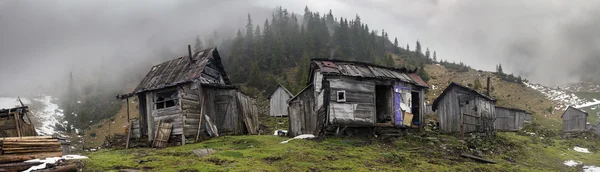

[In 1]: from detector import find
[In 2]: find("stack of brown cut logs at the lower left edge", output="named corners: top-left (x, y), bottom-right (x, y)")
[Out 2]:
top-left (0, 136), bottom-right (62, 163)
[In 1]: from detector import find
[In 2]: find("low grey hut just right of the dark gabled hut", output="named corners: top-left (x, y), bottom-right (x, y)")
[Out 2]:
top-left (494, 106), bottom-right (531, 131)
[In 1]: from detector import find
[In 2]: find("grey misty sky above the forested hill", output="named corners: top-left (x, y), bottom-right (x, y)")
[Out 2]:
top-left (0, 0), bottom-right (600, 95)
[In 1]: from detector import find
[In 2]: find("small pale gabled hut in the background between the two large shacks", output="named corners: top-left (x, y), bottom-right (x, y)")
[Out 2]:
top-left (269, 84), bottom-right (292, 117)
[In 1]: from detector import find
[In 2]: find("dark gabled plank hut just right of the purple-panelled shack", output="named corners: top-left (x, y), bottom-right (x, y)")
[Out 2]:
top-left (433, 83), bottom-right (496, 133)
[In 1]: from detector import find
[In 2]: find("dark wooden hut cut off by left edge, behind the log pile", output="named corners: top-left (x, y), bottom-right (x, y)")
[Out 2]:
top-left (0, 106), bottom-right (37, 137)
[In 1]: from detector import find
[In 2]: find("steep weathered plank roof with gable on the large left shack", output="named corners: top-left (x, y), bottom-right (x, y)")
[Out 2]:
top-left (118, 48), bottom-right (231, 97)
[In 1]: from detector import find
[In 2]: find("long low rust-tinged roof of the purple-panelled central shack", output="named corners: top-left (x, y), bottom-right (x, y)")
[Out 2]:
top-left (312, 59), bottom-right (429, 88)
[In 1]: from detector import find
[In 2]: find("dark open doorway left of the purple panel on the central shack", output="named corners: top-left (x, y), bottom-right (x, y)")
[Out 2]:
top-left (375, 85), bottom-right (394, 123)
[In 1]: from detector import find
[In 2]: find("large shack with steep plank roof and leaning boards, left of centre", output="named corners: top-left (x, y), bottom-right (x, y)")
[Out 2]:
top-left (117, 45), bottom-right (258, 144)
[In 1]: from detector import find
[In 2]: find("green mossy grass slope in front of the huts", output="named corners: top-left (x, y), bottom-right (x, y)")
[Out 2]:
top-left (83, 132), bottom-right (600, 171)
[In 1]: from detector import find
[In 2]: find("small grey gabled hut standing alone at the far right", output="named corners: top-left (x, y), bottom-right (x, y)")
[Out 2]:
top-left (560, 106), bottom-right (588, 132)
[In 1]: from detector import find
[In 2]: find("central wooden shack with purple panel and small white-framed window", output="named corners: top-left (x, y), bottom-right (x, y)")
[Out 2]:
top-left (288, 59), bottom-right (428, 136)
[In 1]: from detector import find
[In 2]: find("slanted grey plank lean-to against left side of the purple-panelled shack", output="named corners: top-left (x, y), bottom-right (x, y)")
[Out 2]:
top-left (288, 86), bottom-right (317, 136)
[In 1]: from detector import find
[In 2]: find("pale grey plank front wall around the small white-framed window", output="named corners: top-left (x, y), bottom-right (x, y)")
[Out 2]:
top-left (328, 77), bottom-right (375, 126)
